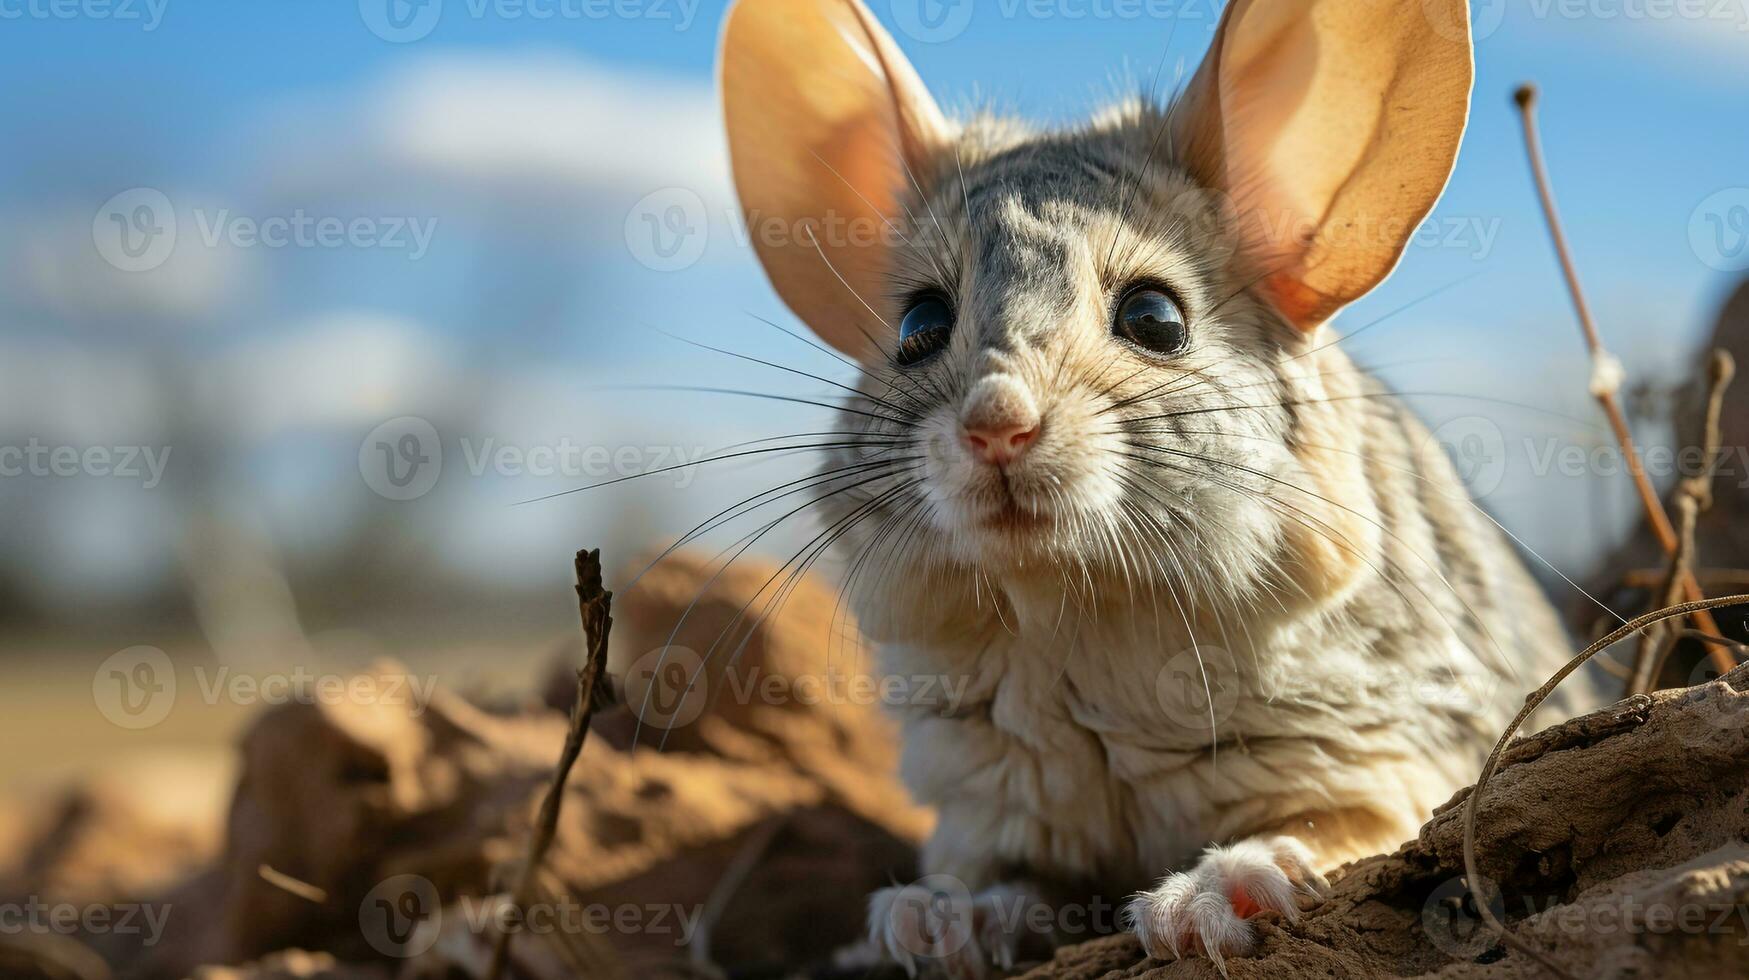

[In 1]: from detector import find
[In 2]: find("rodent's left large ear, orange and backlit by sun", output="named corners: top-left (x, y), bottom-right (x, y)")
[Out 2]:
top-left (722, 0), bottom-right (948, 357)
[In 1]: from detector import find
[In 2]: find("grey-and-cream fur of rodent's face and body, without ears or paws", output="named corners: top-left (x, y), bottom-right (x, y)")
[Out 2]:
top-left (820, 102), bottom-right (1595, 931)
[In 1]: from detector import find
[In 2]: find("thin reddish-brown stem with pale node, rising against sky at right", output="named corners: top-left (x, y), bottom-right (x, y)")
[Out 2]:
top-left (1513, 84), bottom-right (1723, 647)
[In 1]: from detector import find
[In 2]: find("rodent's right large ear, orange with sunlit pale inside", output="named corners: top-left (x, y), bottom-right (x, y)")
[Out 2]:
top-left (1174, 0), bottom-right (1473, 329)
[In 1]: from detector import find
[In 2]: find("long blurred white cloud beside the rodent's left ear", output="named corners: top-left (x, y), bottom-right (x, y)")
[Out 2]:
top-left (255, 53), bottom-right (728, 214)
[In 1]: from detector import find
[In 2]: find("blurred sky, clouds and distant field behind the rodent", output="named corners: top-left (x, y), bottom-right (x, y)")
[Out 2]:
top-left (0, 0), bottom-right (1749, 789)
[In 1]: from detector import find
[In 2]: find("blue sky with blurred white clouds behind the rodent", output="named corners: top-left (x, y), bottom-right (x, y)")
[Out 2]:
top-left (0, 0), bottom-right (1749, 605)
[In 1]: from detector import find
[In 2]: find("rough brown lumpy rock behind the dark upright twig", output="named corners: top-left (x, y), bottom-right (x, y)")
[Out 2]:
top-left (109, 557), bottom-right (929, 977)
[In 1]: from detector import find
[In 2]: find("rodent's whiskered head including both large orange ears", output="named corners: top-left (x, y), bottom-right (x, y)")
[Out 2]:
top-left (722, 0), bottom-right (1471, 626)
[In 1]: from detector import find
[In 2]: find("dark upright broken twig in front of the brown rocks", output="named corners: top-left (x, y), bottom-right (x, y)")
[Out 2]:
top-left (486, 550), bottom-right (614, 980)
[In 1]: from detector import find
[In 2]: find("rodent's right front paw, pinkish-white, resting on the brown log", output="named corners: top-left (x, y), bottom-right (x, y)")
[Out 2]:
top-left (1125, 837), bottom-right (1329, 977)
